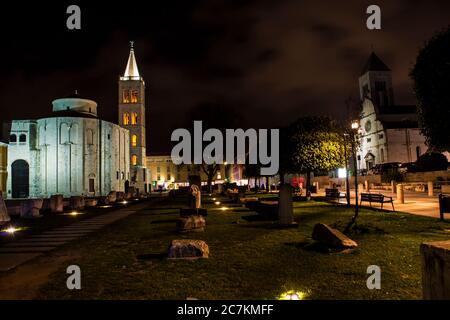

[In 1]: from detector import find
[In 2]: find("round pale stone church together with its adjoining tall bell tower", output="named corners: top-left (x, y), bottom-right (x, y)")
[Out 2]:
top-left (4, 43), bottom-right (150, 199)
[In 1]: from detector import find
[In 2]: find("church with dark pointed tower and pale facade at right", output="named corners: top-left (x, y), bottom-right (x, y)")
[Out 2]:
top-left (358, 53), bottom-right (428, 170)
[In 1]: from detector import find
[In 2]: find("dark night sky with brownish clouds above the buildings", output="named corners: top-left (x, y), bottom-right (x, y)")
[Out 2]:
top-left (0, 0), bottom-right (450, 153)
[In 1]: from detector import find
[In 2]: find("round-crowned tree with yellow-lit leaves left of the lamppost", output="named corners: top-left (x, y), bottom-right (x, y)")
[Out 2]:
top-left (282, 117), bottom-right (344, 190)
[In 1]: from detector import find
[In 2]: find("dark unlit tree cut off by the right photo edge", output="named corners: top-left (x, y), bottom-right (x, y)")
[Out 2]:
top-left (410, 28), bottom-right (450, 151)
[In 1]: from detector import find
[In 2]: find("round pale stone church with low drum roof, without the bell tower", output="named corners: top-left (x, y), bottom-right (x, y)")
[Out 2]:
top-left (7, 94), bottom-right (130, 198)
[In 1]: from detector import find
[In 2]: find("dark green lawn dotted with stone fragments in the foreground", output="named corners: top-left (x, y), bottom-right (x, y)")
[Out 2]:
top-left (39, 197), bottom-right (450, 299)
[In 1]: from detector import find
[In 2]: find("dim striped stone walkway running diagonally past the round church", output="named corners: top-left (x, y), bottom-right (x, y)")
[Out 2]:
top-left (0, 199), bottom-right (163, 272)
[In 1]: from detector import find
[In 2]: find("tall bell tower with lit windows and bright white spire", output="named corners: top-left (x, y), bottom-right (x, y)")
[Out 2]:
top-left (119, 42), bottom-right (150, 193)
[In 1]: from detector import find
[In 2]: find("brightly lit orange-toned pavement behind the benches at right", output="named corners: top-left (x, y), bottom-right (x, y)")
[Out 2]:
top-left (319, 190), bottom-right (450, 219)
